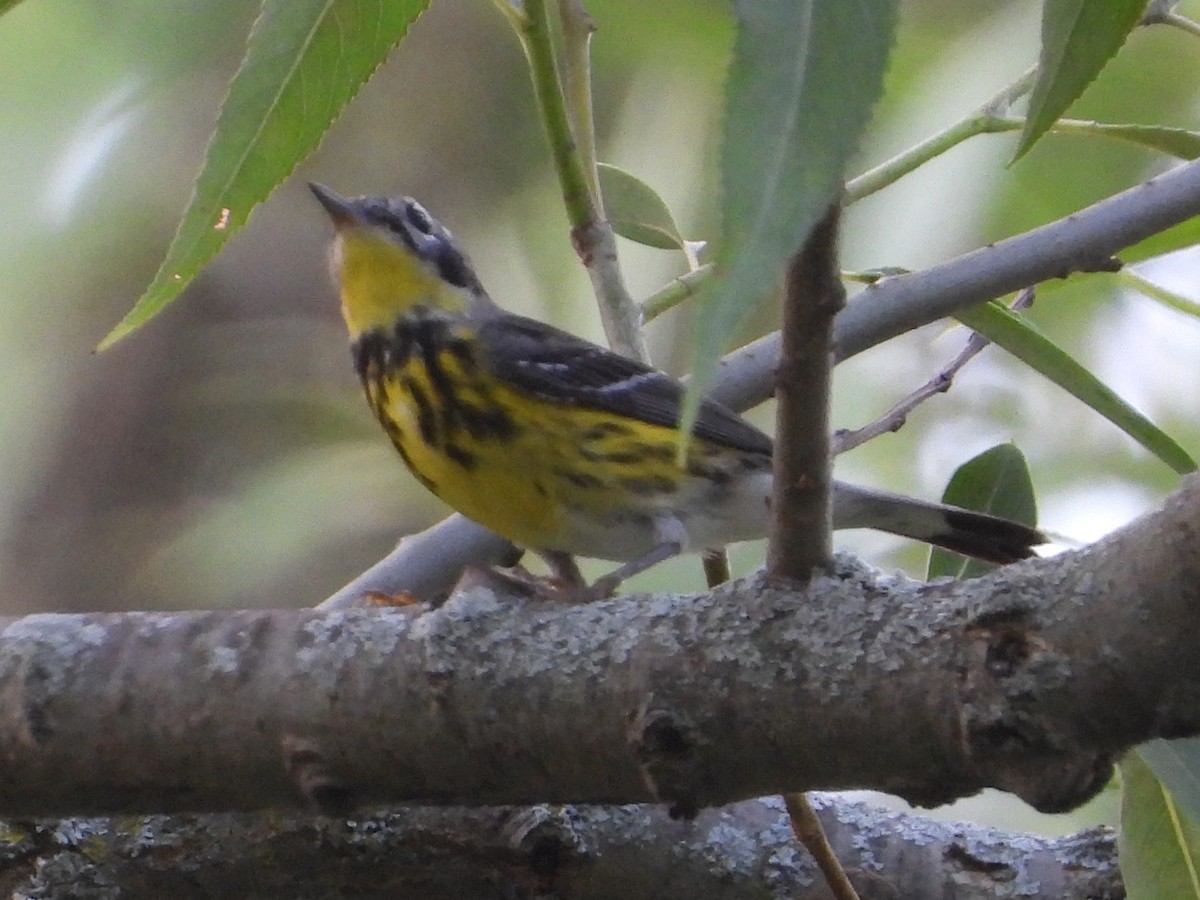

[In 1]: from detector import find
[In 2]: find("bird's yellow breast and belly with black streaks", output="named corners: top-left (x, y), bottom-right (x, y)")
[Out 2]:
top-left (364, 338), bottom-right (686, 559)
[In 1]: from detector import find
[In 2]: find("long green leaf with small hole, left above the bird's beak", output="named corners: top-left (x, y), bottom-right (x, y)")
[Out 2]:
top-left (100, 0), bottom-right (427, 349)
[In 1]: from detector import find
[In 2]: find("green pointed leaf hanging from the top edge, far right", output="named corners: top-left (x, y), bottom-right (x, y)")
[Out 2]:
top-left (1013, 0), bottom-right (1146, 162)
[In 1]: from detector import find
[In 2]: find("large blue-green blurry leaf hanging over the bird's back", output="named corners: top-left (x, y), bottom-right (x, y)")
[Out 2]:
top-left (684, 0), bottom-right (898, 433)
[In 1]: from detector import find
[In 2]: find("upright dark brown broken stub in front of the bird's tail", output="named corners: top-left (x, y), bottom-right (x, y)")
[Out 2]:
top-left (767, 203), bottom-right (846, 584)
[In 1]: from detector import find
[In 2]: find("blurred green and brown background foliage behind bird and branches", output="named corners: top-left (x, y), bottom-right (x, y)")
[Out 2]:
top-left (0, 0), bottom-right (1200, 830)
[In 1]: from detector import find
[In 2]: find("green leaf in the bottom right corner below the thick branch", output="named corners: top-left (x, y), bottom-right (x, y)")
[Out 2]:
top-left (1117, 752), bottom-right (1200, 900)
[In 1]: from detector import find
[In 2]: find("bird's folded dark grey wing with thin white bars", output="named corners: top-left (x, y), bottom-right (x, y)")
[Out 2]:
top-left (479, 313), bottom-right (772, 454)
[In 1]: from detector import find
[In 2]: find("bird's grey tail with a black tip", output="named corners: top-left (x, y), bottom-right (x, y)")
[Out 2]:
top-left (833, 482), bottom-right (1049, 564)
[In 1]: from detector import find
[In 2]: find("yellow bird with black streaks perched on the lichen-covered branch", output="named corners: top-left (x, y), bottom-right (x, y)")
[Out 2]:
top-left (311, 185), bottom-right (1046, 595)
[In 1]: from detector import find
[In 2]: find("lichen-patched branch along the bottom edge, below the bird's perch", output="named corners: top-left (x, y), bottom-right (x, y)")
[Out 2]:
top-left (0, 796), bottom-right (1124, 900)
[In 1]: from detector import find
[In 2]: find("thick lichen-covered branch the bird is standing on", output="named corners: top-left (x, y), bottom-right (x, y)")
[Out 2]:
top-left (7, 479), bottom-right (1200, 815)
